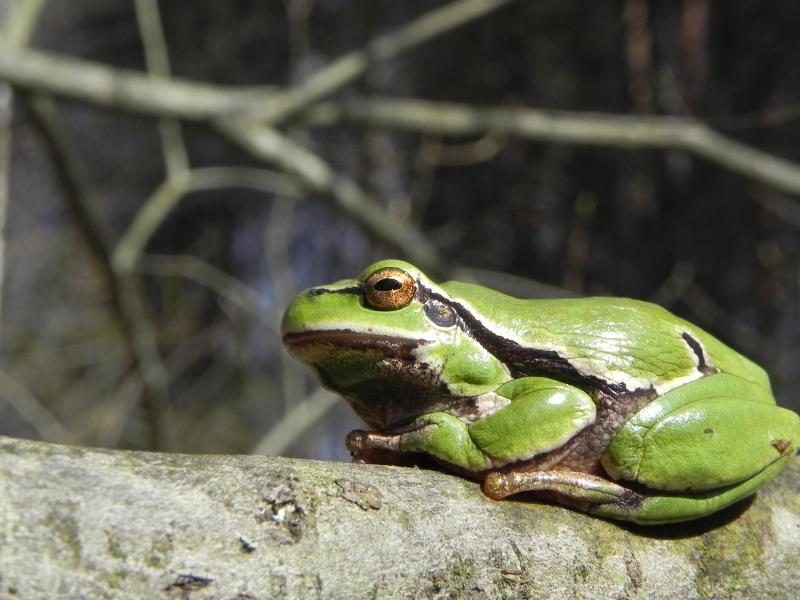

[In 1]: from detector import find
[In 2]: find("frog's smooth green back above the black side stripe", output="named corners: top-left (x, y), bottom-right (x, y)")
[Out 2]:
top-left (443, 282), bottom-right (769, 393)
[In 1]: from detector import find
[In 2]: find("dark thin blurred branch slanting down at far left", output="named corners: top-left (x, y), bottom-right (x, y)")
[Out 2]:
top-left (28, 96), bottom-right (169, 450)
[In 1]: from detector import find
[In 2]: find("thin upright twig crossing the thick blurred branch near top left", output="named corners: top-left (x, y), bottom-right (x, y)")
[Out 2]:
top-left (134, 0), bottom-right (189, 179)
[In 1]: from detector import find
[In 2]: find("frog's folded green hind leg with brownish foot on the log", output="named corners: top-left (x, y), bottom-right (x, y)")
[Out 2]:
top-left (484, 374), bottom-right (800, 524)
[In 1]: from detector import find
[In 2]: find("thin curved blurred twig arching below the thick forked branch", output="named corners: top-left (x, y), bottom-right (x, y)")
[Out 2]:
top-left (113, 167), bottom-right (307, 272)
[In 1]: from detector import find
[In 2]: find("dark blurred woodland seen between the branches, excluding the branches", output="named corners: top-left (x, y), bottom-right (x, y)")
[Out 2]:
top-left (0, 0), bottom-right (800, 458)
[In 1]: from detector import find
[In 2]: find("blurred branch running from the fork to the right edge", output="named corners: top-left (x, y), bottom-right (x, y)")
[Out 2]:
top-left (304, 98), bottom-right (800, 195)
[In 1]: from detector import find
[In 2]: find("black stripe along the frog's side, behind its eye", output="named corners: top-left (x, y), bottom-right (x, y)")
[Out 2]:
top-left (425, 290), bottom-right (631, 396)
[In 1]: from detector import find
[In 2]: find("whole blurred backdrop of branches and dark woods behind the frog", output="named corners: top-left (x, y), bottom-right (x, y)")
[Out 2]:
top-left (0, 0), bottom-right (800, 459)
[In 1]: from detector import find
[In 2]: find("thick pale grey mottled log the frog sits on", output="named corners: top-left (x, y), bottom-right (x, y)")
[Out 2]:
top-left (0, 437), bottom-right (800, 600)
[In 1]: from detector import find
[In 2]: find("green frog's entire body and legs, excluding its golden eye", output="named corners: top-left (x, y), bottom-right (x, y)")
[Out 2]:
top-left (282, 260), bottom-right (800, 524)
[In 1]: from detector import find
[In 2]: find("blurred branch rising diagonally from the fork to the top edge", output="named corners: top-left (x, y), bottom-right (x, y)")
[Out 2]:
top-left (231, 0), bottom-right (513, 125)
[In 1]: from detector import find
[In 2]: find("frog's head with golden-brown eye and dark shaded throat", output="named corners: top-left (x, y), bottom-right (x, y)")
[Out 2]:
top-left (281, 260), bottom-right (509, 429)
